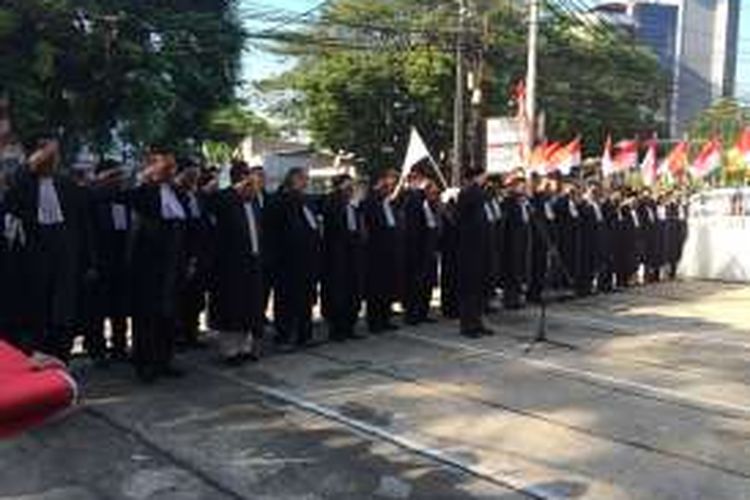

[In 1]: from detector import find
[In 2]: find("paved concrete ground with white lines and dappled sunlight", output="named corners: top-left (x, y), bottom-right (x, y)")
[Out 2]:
top-left (0, 283), bottom-right (750, 500)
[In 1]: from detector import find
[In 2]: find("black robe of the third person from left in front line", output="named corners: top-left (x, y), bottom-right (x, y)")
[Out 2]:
top-left (206, 189), bottom-right (264, 336)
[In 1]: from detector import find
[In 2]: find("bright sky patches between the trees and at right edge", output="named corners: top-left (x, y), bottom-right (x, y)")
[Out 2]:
top-left (243, 0), bottom-right (750, 102)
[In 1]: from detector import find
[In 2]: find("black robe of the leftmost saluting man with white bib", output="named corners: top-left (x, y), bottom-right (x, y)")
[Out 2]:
top-left (6, 170), bottom-right (91, 359)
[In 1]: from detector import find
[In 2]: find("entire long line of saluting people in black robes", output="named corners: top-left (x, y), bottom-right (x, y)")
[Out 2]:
top-left (0, 137), bottom-right (687, 382)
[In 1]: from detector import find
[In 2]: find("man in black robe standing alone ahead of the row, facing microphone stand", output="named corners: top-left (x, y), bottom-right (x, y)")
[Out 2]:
top-left (456, 170), bottom-right (492, 338)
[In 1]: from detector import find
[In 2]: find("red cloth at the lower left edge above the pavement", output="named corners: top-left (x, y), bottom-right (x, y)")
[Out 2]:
top-left (0, 341), bottom-right (77, 439)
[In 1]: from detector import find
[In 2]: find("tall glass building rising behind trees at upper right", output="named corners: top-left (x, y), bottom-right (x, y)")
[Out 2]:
top-left (592, 0), bottom-right (741, 137)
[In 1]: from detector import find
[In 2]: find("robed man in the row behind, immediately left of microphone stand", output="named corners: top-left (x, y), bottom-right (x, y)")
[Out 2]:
top-left (502, 174), bottom-right (531, 309)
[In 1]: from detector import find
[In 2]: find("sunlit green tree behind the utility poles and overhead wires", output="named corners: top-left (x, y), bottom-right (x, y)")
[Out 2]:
top-left (265, 0), bottom-right (668, 174)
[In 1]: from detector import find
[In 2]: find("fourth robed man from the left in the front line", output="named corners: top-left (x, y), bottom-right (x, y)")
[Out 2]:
top-left (271, 168), bottom-right (322, 347)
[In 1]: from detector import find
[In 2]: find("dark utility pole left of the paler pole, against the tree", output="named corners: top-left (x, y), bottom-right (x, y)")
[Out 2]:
top-left (451, 0), bottom-right (468, 187)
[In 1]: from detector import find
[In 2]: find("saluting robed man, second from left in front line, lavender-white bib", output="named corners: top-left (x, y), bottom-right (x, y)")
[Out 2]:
top-left (128, 148), bottom-right (187, 383)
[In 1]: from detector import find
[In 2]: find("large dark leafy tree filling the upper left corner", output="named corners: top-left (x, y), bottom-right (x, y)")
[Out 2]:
top-left (0, 0), bottom-right (244, 156)
